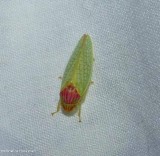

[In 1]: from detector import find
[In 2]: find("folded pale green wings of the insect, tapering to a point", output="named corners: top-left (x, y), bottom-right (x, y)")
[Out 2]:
top-left (61, 34), bottom-right (93, 95)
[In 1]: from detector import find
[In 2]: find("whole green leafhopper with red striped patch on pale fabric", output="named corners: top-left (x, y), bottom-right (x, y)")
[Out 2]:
top-left (51, 34), bottom-right (94, 122)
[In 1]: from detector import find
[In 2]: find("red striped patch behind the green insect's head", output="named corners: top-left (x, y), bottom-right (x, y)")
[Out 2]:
top-left (60, 84), bottom-right (80, 104)
